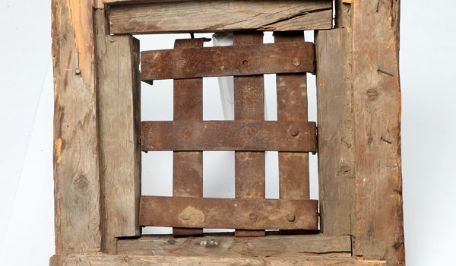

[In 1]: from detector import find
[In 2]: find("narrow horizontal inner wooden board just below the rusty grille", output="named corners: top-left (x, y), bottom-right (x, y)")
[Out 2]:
top-left (117, 234), bottom-right (351, 257)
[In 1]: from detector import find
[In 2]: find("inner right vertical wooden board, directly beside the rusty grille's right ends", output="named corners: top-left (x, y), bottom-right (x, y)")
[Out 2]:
top-left (315, 3), bottom-right (355, 235)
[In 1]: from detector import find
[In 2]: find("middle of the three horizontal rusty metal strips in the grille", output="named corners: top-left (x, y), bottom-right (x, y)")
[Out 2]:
top-left (141, 121), bottom-right (317, 152)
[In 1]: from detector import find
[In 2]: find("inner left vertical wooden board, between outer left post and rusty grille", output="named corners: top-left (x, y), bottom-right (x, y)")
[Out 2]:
top-left (95, 10), bottom-right (141, 253)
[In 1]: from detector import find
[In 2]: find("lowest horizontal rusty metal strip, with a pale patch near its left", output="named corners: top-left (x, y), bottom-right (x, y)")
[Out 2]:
top-left (139, 196), bottom-right (318, 230)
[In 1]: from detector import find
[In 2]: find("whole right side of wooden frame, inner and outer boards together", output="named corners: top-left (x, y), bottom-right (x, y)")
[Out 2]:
top-left (317, 0), bottom-right (404, 265)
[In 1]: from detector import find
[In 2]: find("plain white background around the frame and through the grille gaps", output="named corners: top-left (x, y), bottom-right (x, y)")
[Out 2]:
top-left (0, 0), bottom-right (456, 266)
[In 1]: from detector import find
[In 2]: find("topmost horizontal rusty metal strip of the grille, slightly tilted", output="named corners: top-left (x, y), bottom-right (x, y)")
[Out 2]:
top-left (141, 42), bottom-right (315, 80)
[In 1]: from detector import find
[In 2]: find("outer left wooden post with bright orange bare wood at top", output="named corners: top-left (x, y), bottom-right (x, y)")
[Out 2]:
top-left (52, 0), bottom-right (102, 254)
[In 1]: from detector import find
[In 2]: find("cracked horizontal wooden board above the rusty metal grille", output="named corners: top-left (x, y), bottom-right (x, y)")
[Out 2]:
top-left (108, 0), bottom-right (332, 34)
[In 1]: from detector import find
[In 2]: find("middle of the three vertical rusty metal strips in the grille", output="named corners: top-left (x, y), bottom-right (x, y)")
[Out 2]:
top-left (233, 32), bottom-right (268, 236)
